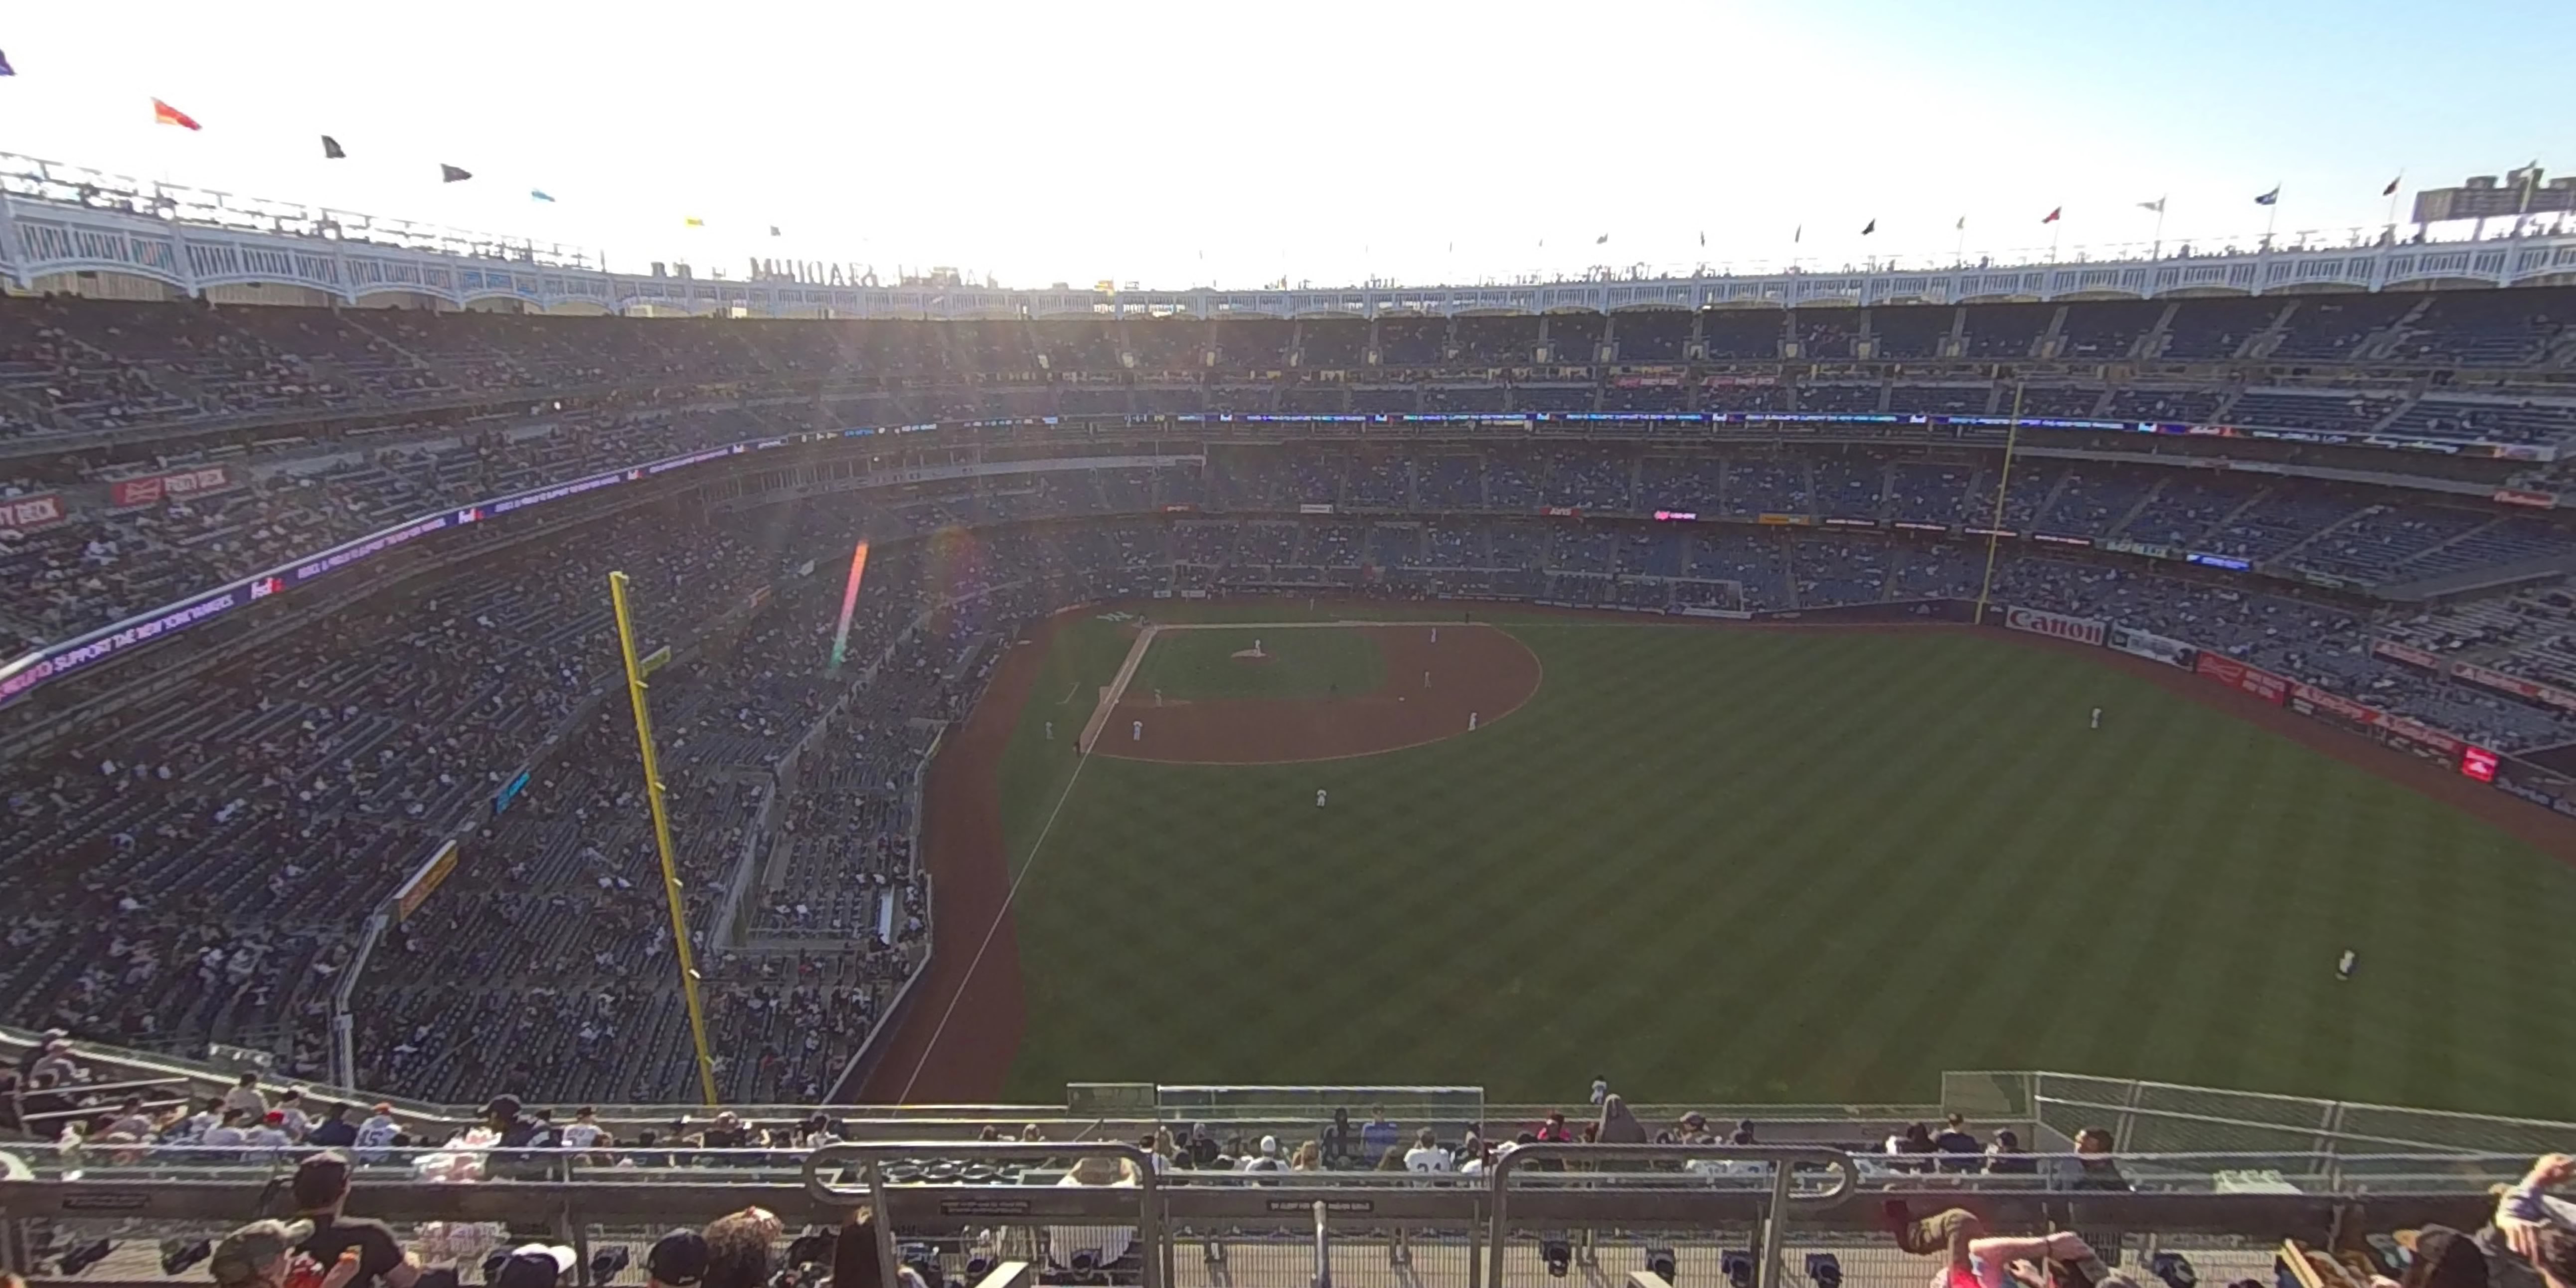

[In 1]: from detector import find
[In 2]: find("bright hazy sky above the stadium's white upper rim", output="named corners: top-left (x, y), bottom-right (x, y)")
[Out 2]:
top-left (0, 0), bottom-right (2576, 289)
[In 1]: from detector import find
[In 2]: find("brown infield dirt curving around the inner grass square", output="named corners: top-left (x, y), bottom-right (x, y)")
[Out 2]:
top-left (1092, 621), bottom-right (1540, 765)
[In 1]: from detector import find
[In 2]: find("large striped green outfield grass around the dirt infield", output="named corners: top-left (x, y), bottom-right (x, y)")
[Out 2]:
top-left (973, 608), bottom-right (2576, 1118)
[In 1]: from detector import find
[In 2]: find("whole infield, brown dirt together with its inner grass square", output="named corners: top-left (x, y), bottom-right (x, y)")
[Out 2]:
top-left (1092, 621), bottom-right (1540, 765)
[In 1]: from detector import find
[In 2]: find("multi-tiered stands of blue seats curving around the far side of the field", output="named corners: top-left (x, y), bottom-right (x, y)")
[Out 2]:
top-left (0, 289), bottom-right (2576, 1103)
